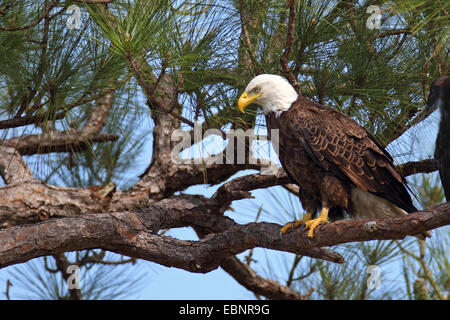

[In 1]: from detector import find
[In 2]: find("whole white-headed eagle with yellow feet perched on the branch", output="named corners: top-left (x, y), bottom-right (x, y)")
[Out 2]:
top-left (238, 74), bottom-right (427, 239)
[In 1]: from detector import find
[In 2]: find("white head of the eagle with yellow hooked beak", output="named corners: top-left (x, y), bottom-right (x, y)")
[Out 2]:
top-left (238, 74), bottom-right (298, 117)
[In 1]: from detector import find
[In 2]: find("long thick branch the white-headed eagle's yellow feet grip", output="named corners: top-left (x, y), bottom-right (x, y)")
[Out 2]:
top-left (0, 203), bottom-right (450, 272)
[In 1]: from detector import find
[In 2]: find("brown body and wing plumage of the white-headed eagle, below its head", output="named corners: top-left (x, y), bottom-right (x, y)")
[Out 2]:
top-left (266, 97), bottom-right (416, 214)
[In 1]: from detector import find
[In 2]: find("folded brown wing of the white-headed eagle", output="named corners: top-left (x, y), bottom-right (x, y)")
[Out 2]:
top-left (285, 98), bottom-right (416, 212)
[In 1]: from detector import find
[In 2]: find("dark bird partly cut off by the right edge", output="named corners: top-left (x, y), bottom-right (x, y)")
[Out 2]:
top-left (427, 76), bottom-right (450, 201)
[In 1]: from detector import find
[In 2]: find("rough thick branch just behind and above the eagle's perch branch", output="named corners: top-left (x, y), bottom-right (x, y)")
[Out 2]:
top-left (0, 156), bottom-right (436, 228)
